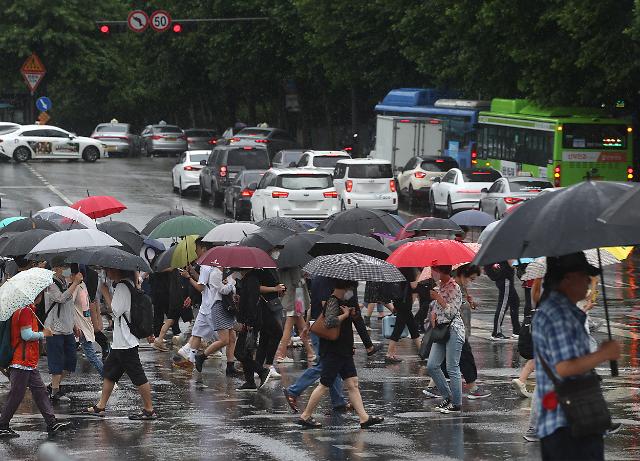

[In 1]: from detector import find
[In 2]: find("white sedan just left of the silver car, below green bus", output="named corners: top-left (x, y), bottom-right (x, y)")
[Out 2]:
top-left (429, 168), bottom-right (502, 217)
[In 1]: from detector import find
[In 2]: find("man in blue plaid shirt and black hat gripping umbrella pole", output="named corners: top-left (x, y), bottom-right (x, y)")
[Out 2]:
top-left (533, 252), bottom-right (620, 460)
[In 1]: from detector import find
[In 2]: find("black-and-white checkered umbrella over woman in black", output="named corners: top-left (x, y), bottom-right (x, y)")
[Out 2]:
top-left (302, 253), bottom-right (406, 283)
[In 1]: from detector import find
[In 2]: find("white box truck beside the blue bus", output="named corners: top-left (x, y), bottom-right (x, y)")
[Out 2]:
top-left (371, 115), bottom-right (445, 171)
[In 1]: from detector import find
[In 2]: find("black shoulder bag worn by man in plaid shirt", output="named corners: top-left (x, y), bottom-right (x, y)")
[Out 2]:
top-left (538, 355), bottom-right (611, 437)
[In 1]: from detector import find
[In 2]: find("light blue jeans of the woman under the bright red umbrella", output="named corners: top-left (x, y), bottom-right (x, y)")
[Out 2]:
top-left (427, 328), bottom-right (464, 405)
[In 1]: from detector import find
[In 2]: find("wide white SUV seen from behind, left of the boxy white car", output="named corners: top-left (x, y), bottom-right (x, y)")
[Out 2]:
top-left (251, 168), bottom-right (340, 221)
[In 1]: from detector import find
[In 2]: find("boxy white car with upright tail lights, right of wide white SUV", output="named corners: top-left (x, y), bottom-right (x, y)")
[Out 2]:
top-left (333, 158), bottom-right (398, 211)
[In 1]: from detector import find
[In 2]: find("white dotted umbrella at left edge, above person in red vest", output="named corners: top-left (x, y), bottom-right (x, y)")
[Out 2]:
top-left (0, 267), bottom-right (53, 322)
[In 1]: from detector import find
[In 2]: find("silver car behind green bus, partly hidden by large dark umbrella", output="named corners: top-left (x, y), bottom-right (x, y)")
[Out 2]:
top-left (479, 176), bottom-right (553, 219)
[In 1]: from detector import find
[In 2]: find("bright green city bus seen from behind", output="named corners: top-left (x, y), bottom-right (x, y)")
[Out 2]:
top-left (472, 99), bottom-right (634, 187)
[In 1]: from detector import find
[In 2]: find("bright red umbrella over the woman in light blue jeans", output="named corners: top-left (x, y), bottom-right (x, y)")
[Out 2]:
top-left (387, 240), bottom-right (476, 267)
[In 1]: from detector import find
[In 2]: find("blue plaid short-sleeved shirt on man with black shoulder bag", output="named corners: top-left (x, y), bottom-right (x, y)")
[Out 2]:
top-left (532, 291), bottom-right (591, 437)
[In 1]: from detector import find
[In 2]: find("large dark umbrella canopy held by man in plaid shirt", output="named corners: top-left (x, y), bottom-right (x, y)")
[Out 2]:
top-left (474, 181), bottom-right (638, 265)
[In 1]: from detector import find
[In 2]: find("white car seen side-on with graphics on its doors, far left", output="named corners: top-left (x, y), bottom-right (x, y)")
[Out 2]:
top-left (0, 125), bottom-right (105, 163)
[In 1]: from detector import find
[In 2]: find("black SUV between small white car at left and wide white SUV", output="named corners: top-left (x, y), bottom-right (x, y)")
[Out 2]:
top-left (200, 142), bottom-right (271, 207)
